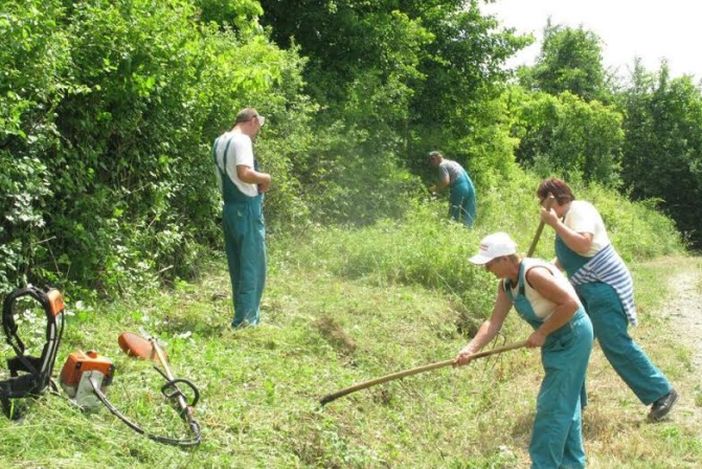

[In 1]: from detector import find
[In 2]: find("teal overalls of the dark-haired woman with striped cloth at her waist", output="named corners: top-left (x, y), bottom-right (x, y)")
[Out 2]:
top-left (556, 235), bottom-right (672, 405)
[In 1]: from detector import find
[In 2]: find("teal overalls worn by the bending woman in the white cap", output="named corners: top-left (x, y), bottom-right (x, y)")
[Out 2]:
top-left (504, 259), bottom-right (592, 468)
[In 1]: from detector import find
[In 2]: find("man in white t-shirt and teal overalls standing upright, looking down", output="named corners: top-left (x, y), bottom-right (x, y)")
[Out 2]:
top-left (212, 108), bottom-right (271, 327)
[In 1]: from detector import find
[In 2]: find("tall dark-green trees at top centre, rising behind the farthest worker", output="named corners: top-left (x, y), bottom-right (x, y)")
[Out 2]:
top-left (261, 0), bottom-right (528, 200)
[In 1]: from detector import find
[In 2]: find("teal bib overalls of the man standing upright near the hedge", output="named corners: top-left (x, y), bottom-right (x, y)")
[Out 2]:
top-left (212, 135), bottom-right (266, 327)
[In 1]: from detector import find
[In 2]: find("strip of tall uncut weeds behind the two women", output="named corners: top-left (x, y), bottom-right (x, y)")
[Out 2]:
top-left (275, 168), bottom-right (682, 322)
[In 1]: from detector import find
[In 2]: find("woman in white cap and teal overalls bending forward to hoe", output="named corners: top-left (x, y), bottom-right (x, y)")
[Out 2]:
top-left (455, 233), bottom-right (593, 468)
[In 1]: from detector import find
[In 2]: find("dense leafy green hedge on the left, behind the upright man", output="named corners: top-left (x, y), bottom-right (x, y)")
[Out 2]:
top-left (0, 0), bottom-right (313, 291)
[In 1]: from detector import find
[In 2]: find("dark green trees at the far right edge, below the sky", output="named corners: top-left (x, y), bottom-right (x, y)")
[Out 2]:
top-left (621, 60), bottom-right (702, 246)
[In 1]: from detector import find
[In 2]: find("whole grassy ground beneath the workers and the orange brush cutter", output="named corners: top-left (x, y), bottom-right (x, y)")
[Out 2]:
top-left (0, 193), bottom-right (702, 468)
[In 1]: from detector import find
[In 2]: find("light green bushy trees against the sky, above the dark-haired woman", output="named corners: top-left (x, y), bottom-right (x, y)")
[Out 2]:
top-left (510, 21), bottom-right (624, 187)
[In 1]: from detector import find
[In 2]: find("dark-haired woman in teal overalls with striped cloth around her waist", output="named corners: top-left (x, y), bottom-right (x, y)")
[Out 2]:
top-left (537, 178), bottom-right (678, 421)
